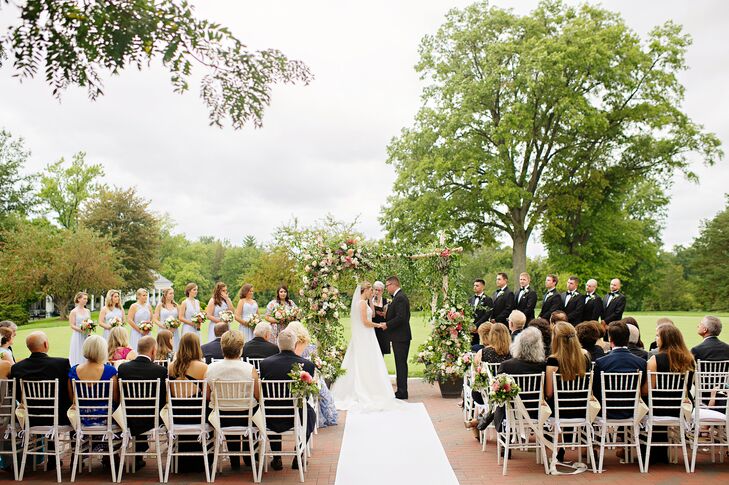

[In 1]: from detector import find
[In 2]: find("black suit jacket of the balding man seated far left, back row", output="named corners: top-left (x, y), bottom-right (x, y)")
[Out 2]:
top-left (9, 352), bottom-right (72, 426)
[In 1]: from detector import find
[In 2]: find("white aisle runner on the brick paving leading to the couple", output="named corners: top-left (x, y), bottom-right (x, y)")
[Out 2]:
top-left (336, 403), bottom-right (458, 485)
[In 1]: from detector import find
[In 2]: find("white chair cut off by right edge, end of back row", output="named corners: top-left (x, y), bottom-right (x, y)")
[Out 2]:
top-left (690, 360), bottom-right (729, 473)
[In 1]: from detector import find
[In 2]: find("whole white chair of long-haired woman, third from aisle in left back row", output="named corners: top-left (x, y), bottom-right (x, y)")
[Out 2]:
top-left (165, 379), bottom-right (213, 482)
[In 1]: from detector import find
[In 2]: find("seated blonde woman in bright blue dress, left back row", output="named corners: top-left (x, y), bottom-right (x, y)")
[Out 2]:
top-left (68, 335), bottom-right (119, 426)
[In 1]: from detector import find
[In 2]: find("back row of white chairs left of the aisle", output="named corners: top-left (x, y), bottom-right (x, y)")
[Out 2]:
top-left (0, 379), bottom-right (311, 483)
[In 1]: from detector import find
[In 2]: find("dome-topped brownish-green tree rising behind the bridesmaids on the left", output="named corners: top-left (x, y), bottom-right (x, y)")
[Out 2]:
top-left (81, 188), bottom-right (161, 289)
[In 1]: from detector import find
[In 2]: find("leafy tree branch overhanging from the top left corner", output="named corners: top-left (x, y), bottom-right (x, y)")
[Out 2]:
top-left (0, 0), bottom-right (311, 128)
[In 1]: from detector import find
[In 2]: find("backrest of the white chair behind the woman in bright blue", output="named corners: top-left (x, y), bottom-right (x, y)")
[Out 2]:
top-left (72, 379), bottom-right (114, 431)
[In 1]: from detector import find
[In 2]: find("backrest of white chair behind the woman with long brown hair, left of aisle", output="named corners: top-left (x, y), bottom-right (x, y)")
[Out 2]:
top-left (167, 379), bottom-right (208, 432)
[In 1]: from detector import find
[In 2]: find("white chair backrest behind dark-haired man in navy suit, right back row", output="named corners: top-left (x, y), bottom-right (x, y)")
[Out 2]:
top-left (600, 371), bottom-right (643, 419)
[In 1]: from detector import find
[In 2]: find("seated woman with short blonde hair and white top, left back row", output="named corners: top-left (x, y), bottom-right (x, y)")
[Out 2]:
top-left (205, 324), bottom-right (260, 469)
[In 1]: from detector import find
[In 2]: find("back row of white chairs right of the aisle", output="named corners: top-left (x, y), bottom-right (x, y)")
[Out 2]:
top-left (464, 361), bottom-right (729, 475)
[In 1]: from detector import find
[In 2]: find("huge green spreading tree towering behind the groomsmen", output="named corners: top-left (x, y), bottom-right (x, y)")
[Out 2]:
top-left (382, 1), bottom-right (721, 274)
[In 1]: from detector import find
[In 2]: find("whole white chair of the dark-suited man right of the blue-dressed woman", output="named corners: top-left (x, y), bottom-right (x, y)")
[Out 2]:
top-left (116, 379), bottom-right (166, 483)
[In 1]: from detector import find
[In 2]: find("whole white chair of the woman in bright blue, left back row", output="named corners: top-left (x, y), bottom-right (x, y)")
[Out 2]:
top-left (71, 379), bottom-right (121, 482)
